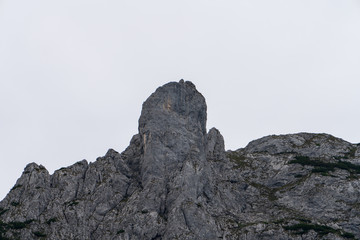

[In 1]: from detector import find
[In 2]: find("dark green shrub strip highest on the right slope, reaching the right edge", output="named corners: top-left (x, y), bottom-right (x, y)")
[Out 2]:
top-left (289, 156), bottom-right (360, 176)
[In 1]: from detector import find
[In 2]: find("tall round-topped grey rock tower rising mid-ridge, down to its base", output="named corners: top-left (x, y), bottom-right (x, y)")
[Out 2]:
top-left (134, 80), bottom-right (216, 238)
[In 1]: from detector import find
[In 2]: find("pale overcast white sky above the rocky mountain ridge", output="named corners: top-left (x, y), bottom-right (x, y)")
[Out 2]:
top-left (0, 0), bottom-right (360, 199)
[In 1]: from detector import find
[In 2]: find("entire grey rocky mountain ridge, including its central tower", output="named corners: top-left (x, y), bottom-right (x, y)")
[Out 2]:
top-left (0, 80), bottom-right (360, 240)
